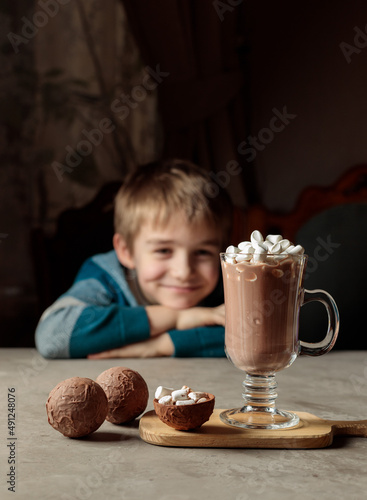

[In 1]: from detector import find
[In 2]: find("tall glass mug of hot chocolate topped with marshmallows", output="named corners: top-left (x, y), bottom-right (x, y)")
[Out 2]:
top-left (220, 231), bottom-right (339, 429)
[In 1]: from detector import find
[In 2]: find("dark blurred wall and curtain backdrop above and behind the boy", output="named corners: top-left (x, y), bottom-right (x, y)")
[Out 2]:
top-left (0, 0), bottom-right (367, 348)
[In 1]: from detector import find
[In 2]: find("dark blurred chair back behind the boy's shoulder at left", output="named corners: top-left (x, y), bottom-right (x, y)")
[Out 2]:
top-left (31, 181), bottom-right (121, 315)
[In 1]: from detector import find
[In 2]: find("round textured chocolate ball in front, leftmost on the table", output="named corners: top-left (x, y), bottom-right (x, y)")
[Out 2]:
top-left (46, 377), bottom-right (108, 438)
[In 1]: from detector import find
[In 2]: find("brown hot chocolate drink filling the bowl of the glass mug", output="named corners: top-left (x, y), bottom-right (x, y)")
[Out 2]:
top-left (222, 255), bottom-right (305, 375)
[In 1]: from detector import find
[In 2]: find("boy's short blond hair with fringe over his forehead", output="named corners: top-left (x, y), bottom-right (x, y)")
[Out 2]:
top-left (114, 160), bottom-right (232, 250)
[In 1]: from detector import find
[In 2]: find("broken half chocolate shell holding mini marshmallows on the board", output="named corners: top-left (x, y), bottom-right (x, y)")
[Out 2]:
top-left (153, 393), bottom-right (215, 431)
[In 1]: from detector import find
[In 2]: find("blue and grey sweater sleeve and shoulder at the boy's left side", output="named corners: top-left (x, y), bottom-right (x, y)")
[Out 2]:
top-left (35, 253), bottom-right (155, 358)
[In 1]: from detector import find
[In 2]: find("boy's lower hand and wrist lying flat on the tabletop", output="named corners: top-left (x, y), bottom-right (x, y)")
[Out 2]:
top-left (88, 333), bottom-right (174, 359)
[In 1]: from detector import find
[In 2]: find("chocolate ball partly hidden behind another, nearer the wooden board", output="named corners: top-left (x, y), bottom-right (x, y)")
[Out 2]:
top-left (96, 366), bottom-right (149, 424)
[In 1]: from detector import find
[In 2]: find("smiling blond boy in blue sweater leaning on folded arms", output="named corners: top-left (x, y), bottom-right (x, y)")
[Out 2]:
top-left (36, 160), bottom-right (231, 359)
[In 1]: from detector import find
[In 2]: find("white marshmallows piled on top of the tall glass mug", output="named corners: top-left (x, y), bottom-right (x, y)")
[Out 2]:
top-left (225, 230), bottom-right (305, 264)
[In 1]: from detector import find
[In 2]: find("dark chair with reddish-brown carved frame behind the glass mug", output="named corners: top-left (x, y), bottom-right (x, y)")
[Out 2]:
top-left (236, 165), bottom-right (367, 349)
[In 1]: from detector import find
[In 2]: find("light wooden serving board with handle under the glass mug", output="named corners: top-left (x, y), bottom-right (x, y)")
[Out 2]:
top-left (139, 409), bottom-right (367, 448)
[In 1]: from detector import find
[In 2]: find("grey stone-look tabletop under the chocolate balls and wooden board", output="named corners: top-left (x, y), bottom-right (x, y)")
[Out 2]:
top-left (0, 349), bottom-right (367, 500)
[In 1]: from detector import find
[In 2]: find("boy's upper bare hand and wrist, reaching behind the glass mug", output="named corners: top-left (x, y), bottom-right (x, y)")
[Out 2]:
top-left (176, 304), bottom-right (225, 330)
